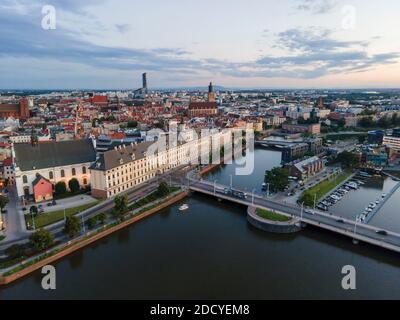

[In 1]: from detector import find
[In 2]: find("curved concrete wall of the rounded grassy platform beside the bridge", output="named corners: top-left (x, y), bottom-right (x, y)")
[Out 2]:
top-left (247, 207), bottom-right (301, 233)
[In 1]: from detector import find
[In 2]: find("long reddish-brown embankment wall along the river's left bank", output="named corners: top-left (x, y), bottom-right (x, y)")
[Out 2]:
top-left (0, 191), bottom-right (188, 285)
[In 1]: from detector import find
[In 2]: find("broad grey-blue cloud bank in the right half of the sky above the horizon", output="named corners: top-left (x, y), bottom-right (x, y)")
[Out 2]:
top-left (208, 28), bottom-right (400, 79)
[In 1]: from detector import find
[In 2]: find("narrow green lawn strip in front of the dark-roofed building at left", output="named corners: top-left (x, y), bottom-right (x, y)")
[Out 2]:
top-left (25, 200), bottom-right (100, 230)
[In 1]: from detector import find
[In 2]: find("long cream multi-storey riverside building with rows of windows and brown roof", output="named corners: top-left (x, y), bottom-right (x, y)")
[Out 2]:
top-left (90, 131), bottom-right (231, 198)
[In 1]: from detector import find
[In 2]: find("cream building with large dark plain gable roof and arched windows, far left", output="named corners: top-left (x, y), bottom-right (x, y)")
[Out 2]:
top-left (13, 137), bottom-right (96, 199)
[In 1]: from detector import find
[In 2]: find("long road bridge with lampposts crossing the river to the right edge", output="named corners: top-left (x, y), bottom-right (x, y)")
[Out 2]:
top-left (188, 178), bottom-right (400, 253)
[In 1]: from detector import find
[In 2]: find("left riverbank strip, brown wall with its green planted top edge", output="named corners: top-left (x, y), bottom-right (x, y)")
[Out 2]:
top-left (0, 191), bottom-right (188, 285)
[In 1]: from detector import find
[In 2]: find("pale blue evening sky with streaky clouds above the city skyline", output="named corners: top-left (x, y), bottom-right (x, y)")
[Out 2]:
top-left (0, 0), bottom-right (400, 89)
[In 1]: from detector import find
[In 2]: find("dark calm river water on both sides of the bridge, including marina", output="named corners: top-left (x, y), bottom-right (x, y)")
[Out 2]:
top-left (0, 149), bottom-right (400, 299)
